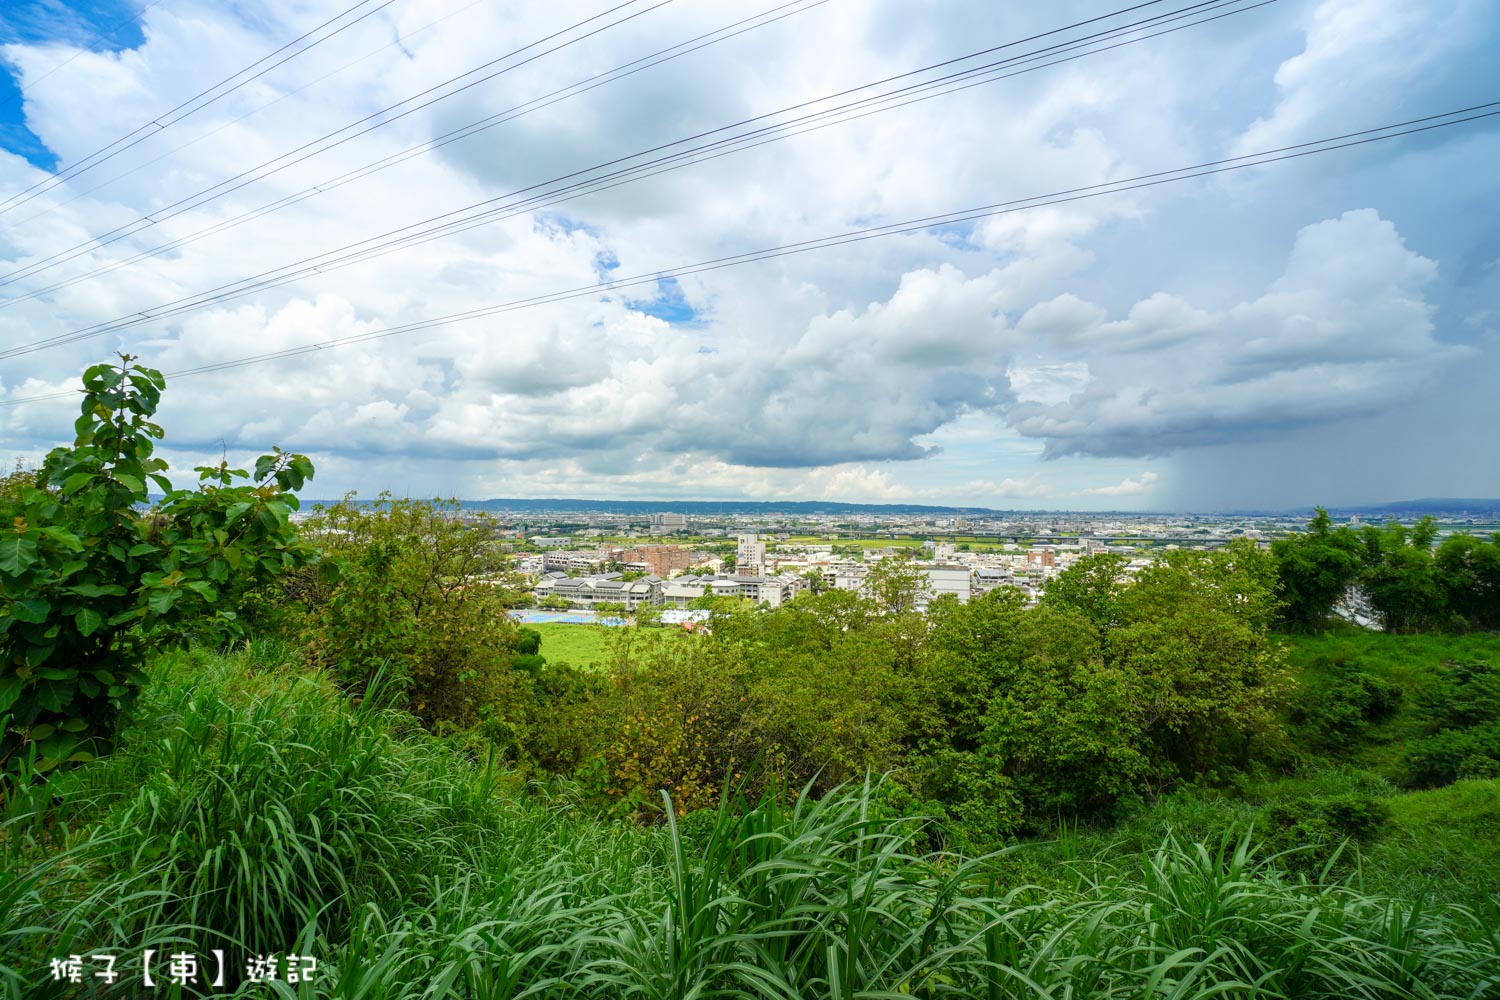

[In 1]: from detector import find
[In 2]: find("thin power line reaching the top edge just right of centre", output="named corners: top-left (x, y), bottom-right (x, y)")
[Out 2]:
top-left (0, 0), bottom-right (830, 299)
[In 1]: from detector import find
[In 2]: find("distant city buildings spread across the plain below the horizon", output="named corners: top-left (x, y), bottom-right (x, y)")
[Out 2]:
top-left (387, 501), bottom-right (1500, 613)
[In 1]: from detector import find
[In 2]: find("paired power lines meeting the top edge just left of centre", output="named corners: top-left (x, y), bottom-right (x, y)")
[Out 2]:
top-left (0, 0), bottom-right (674, 277)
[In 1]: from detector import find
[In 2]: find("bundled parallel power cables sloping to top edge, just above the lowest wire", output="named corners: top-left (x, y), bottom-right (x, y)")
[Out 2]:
top-left (0, 0), bottom-right (1275, 344)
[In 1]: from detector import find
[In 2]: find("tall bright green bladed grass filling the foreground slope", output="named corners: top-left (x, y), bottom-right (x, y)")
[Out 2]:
top-left (0, 651), bottom-right (1500, 1000)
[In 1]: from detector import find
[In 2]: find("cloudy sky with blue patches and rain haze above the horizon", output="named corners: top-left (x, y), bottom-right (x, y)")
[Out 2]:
top-left (0, 0), bottom-right (1500, 511)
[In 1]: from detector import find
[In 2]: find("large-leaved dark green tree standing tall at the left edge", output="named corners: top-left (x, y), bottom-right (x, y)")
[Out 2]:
top-left (0, 355), bottom-right (315, 771)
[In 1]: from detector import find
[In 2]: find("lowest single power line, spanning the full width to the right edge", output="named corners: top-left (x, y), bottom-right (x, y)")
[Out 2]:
top-left (0, 100), bottom-right (1500, 406)
